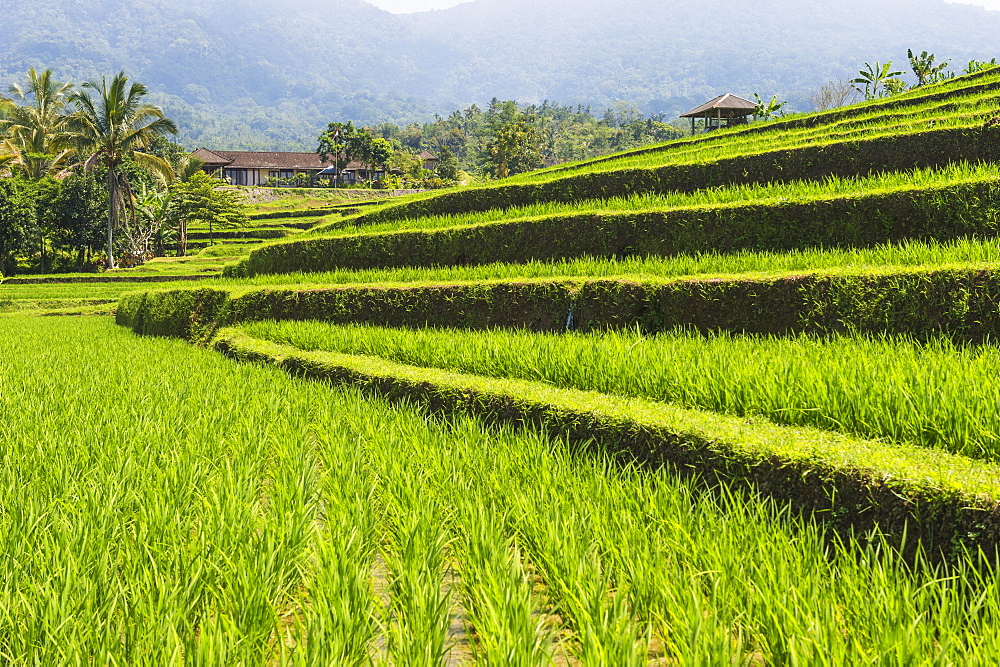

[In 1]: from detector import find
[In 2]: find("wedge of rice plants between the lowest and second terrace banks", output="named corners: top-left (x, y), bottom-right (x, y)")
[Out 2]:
top-left (240, 322), bottom-right (1000, 458)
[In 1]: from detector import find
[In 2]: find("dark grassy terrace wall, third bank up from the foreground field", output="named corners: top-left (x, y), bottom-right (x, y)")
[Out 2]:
top-left (224, 182), bottom-right (1000, 277)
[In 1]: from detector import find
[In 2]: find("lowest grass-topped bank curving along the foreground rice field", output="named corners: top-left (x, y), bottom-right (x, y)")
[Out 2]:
top-left (214, 330), bottom-right (1000, 554)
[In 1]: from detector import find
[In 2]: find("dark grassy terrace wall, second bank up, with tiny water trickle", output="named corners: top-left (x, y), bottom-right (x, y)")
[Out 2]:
top-left (118, 268), bottom-right (1000, 342)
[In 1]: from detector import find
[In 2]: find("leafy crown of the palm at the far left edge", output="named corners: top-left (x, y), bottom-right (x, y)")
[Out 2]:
top-left (0, 68), bottom-right (73, 180)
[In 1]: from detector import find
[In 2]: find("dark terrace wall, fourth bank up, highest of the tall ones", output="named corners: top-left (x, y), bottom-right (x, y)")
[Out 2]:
top-left (338, 125), bottom-right (1000, 228)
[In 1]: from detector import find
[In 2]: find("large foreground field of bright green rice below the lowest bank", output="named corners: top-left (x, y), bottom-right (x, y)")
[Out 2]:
top-left (0, 318), bottom-right (1000, 665)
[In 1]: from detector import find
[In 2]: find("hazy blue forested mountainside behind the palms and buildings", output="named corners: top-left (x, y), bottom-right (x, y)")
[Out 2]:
top-left (0, 0), bottom-right (1000, 149)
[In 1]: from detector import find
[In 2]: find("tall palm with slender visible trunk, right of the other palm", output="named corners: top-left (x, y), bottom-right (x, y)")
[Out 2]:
top-left (70, 72), bottom-right (177, 269)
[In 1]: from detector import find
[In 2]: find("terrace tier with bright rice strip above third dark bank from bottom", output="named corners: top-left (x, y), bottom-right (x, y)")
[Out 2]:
top-left (230, 163), bottom-right (1000, 276)
